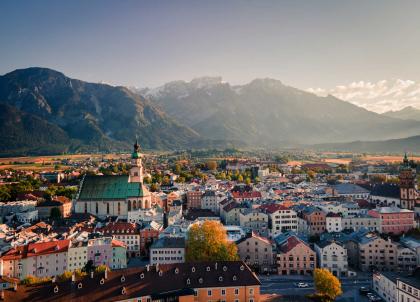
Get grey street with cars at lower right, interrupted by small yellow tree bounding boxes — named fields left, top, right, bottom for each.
left=259, top=275, right=372, bottom=301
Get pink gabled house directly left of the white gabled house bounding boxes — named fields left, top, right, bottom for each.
left=275, top=233, right=316, bottom=275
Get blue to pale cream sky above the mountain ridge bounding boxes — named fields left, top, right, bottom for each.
left=0, top=0, right=420, bottom=112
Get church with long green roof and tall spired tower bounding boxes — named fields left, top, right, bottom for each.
left=75, top=140, right=152, bottom=219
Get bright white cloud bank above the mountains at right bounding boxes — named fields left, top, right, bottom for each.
left=307, top=79, right=420, bottom=113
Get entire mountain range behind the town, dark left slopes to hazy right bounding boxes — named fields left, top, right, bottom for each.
left=0, top=67, right=420, bottom=156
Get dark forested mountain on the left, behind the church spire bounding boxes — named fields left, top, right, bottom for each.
left=0, top=68, right=199, bottom=155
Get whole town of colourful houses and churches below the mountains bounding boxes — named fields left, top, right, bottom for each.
left=0, top=141, right=420, bottom=302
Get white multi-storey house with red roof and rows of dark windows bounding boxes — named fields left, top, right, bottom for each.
left=259, top=203, right=298, bottom=238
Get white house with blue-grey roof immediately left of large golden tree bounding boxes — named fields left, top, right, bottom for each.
left=150, top=237, right=185, bottom=265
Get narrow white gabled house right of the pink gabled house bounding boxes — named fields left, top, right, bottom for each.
left=315, top=241, right=348, bottom=277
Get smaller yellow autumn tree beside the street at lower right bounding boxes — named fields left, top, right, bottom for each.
left=314, top=268, right=343, bottom=301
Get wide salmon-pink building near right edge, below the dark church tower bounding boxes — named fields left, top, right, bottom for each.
left=368, top=207, right=414, bottom=235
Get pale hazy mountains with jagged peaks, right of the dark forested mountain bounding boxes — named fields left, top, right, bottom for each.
left=138, top=77, right=420, bottom=147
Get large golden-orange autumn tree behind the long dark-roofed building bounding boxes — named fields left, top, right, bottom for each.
left=186, top=220, right=239, bottom=261
